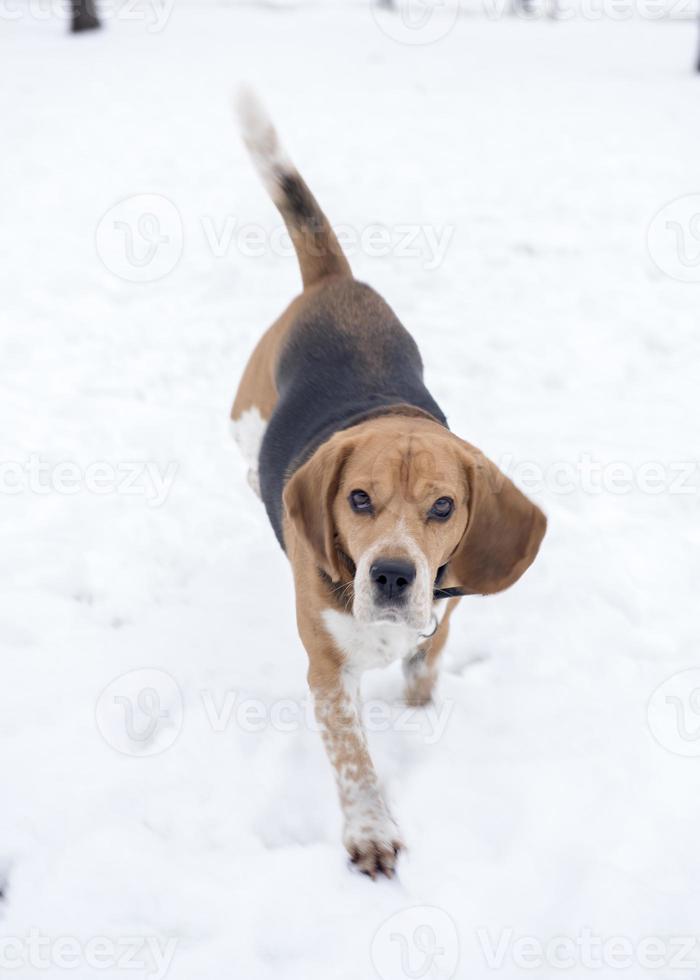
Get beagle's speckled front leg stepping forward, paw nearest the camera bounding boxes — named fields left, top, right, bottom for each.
left=309, top=649, right=403, bottom=878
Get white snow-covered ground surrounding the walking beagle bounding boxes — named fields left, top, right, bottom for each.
left=0, top=4, right=700, bottom=980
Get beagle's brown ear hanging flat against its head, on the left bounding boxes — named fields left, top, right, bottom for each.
left=283, top=433, right=354, bottom=581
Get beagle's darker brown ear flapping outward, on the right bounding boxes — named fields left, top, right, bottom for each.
left=450, top=443, right=547, bottom=595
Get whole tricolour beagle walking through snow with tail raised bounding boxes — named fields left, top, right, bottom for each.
left=231, top=94, right=546, bottom=878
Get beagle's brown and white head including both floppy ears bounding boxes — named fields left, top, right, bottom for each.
left=284, top=416, right=546, bottom=630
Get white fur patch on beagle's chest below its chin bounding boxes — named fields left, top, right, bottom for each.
left=321, top=609, right=420, bottom=673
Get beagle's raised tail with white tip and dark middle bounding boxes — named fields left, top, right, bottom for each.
left=236, top=89, right=352, bottom=287
